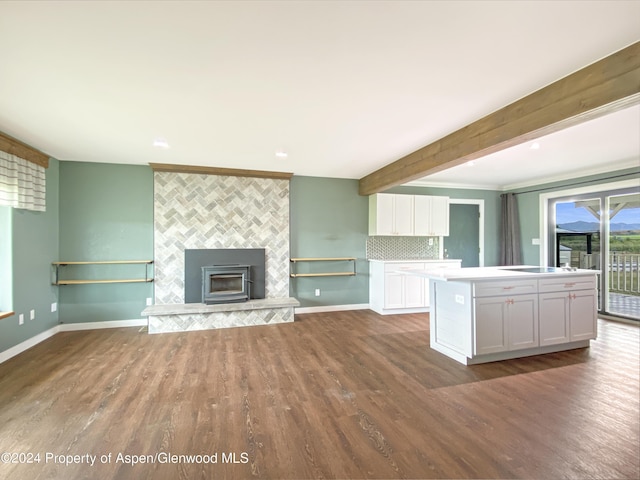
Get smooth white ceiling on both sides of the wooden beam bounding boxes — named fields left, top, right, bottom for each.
left=0, top=0, right=640, bottom=188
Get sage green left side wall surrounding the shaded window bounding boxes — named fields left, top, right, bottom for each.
left=0, top=159, right=59, bottom=352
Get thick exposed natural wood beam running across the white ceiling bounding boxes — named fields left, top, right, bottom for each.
left=359, top=42, right=640, bottom=195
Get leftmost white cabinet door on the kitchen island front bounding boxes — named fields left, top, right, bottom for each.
left=474, top=297, right=508, bottom=355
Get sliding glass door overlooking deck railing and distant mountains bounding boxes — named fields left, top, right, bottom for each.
left=548, top=189, right=640, bottom=320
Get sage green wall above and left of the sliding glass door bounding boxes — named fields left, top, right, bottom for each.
left=513, top=168, right=640, bottom=265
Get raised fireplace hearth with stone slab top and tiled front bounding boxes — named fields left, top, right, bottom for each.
left=142, top=298, right=300, bottom=333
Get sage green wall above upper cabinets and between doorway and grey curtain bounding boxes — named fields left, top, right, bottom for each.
left=388, top=186, right=501, bottom=267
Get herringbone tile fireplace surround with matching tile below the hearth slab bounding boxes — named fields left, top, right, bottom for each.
left=149, top=172, right=293, bottom=333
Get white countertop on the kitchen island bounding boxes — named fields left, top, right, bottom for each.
left=399, top=265, right=600, bottom=281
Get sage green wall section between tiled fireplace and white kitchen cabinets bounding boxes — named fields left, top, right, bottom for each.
left=289, top=176, right=369, bottom=307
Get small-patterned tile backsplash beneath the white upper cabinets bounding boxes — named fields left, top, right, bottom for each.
left=367, top=236, right=440, bottom=260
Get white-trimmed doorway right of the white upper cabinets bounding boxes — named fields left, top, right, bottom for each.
left=442, top=199, right=484, bottom=267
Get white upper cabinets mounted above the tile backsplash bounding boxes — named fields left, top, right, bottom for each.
left=369, top=193, right=449, bottom=237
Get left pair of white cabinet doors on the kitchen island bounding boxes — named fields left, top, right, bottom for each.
left=474, top=294, right=538, bottom=355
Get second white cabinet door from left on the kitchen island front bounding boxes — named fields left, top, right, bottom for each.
left=506, top=295, right=538, bottom=350
